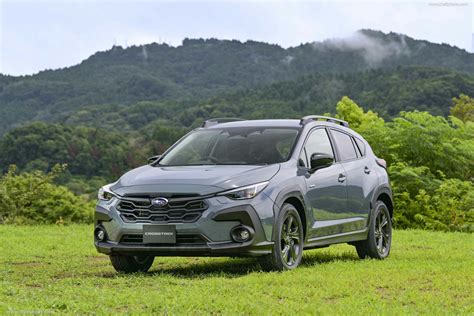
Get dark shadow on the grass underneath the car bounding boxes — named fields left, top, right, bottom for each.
left=100, top=251, right=359, bottom=279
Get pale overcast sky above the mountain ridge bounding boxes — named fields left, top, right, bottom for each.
left=0, top=0, right=474, bottom=75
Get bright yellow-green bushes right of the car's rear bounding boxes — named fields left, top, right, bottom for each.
left=336, top=97, right=474, bottom=232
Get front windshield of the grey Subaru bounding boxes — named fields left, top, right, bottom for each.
left=159, top=127, right=298, bottom=166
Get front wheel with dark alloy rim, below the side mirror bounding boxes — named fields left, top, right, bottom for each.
left=259, top=204, right=304, bottom=271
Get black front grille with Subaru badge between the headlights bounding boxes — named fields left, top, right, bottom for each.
left=117, top=197, right=208, bottom=223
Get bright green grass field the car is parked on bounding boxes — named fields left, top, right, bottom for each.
left=0, top=225, right=474, bottom=315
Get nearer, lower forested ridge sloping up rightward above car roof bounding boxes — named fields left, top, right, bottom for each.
left=57, top=66, right=474, bottom=134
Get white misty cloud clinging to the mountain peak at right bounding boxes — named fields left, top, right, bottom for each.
left=313, top=31, right=410, bottom=66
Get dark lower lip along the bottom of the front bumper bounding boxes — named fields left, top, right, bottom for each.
left=95, top=241, right=273, bottom=257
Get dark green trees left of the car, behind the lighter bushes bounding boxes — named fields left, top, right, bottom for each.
left=0, top=122, right=147, bottom=181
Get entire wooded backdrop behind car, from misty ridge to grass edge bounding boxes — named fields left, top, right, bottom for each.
left=0, top=30, right=474, bottom=232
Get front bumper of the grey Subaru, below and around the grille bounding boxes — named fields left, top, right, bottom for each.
left=95, top=197, right=273, bottom=256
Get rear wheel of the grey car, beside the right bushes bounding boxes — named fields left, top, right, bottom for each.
left=355, top=201, right=392, bottom=259
